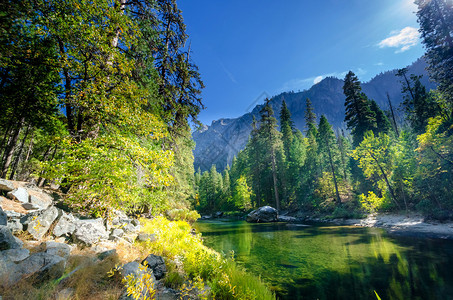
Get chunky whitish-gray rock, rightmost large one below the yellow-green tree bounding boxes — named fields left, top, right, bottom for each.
left=73, top=218, right=109, bottom=246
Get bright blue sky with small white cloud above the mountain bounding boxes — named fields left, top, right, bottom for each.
left=178, top=0, right=424, bottom=125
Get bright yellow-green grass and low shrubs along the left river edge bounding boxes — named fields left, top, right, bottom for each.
left=136, top=217, right=275, bottom=300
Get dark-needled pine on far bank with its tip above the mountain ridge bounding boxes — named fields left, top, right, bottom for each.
left=343, top=71, right=376, bottom=146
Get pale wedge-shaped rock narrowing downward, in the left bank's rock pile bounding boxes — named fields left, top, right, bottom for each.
left=20, top=206, right=59, bottom=240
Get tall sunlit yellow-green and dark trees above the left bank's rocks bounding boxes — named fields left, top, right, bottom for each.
left=0, top=0, right=204, bottom=216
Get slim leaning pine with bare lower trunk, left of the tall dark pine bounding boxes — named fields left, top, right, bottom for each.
left=318, top=115, right=341, bottom=205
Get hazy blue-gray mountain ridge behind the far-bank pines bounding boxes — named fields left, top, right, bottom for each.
left=193, top=59, right=435, bottom=171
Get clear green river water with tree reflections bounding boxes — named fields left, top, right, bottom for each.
left=195, top=220, right=453, bottom=300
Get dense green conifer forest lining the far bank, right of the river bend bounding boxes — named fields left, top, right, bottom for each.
left=195, top=1, right=453, bottom=219
